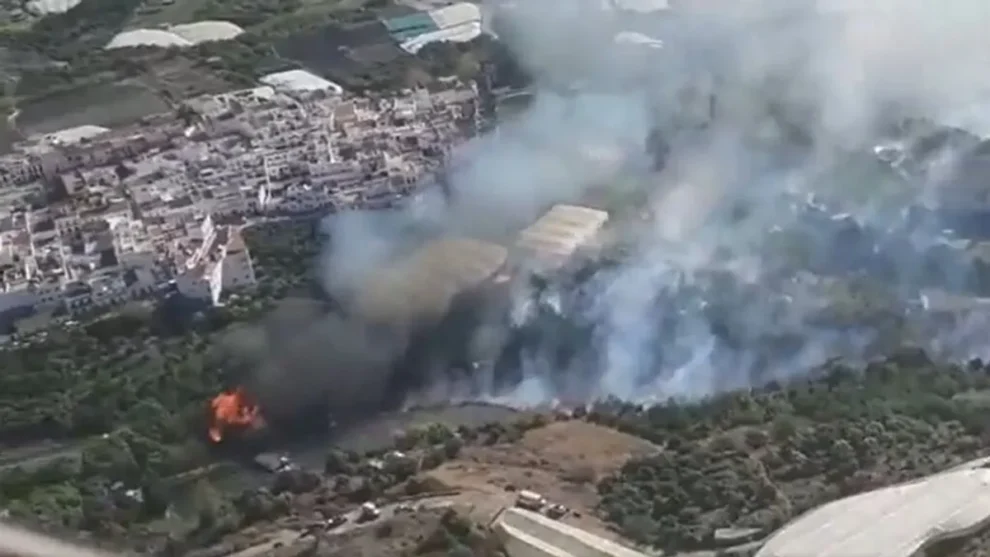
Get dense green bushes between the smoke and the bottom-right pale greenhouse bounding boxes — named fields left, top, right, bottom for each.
left=589, top=351, right=990, bottom=549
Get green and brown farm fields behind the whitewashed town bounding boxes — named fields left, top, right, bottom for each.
left=0, top=0, right=500, bottom=142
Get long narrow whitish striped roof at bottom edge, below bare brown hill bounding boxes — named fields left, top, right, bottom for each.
left=494, top=508, right=646, bottom=557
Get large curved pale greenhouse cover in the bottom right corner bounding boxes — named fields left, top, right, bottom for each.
left=756, top=468, right=990, bottom=557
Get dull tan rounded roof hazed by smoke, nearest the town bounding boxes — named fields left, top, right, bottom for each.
left=355, top=239, right=507, bottom=327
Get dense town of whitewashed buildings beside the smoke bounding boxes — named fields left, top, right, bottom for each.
left=0, top=70, right=478, bottom=322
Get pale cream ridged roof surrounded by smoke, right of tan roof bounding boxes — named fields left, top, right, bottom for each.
left=512, top=205, right=608, bottom=272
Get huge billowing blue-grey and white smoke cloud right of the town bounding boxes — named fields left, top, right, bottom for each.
left=312, top=0, right=990, bottom=403
